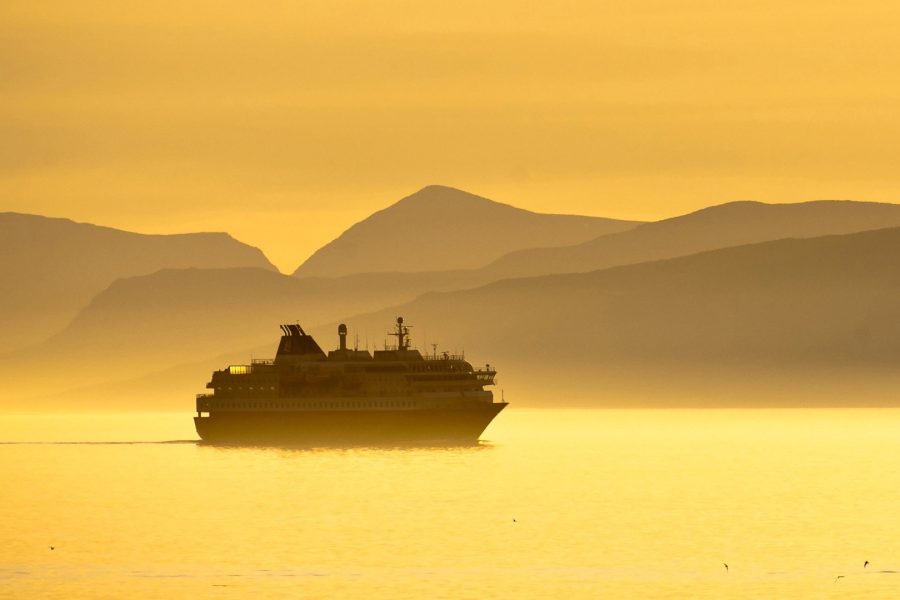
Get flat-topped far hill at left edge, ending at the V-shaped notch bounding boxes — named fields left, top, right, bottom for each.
left=0, top=213, right=274, bottom=351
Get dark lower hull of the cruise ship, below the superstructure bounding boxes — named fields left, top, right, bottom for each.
left=194, top=402, right=506, bottom=445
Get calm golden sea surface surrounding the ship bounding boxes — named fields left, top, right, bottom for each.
left=0, top=405, right=900, bottom=599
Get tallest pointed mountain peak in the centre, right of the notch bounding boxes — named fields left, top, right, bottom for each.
left=294, top=185, right=636, bottom=277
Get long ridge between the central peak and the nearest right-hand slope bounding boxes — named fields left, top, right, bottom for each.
left=482, top=200, right=900, bottom=279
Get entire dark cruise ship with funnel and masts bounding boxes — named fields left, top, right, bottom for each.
left=194, top=317, right=507, bottom=445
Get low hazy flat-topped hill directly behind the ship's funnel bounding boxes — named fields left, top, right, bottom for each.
left=44, top=269, right=486, bottom=366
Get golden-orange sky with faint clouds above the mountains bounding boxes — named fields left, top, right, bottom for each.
left=0, top=0, right=900, bottom=270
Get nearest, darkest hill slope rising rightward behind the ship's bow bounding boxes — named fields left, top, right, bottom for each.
left=322, top=228, right=900, bottom=406
